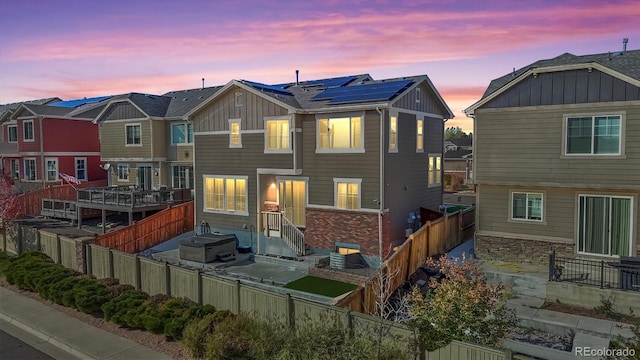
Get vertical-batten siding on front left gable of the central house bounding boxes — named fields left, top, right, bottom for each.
left=190, top=86, right=288, bottom=132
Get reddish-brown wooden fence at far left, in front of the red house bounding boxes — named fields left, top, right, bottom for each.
left=18, top=179, right=107, bottom=217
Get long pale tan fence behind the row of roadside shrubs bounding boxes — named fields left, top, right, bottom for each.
left=86, top=244, right=512, bottom=360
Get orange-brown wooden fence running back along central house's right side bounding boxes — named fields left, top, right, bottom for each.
left=337, top=207, right=475, bottom=314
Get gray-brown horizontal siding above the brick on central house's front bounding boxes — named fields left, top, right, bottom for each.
left=302, top=110, right=380, bottom=209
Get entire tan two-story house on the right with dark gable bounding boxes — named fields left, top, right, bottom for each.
left=465, top=50, right=640, bottom=263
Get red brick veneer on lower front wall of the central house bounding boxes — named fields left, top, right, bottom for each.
left=304, top=208, right=391, bottom=256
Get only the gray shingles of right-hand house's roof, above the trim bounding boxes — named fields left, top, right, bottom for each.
left=482, top=50, right=640, bottom=99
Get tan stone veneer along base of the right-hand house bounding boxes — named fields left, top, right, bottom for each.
left=475, top=234, right=575, bottom=265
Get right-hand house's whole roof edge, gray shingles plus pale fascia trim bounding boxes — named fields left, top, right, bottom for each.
left=465, top=50, right=640, bottom=114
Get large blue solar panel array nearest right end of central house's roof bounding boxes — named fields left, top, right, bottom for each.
left=311, top=80, right=413, bottom=104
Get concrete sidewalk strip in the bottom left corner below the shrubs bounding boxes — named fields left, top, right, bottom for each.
left=0, top=287, right=170, bottom=360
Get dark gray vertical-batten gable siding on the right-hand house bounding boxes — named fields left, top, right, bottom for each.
left=483, top=69, right=640, bottom=108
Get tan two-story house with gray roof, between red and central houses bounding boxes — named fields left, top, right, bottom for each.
left=94, top=87, right=220, bottom=190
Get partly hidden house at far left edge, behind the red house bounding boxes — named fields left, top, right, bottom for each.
left=0, top=97, right=60, bottom=177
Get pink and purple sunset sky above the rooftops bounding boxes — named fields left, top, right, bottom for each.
left=0, top=0, right=640, bottom=131
